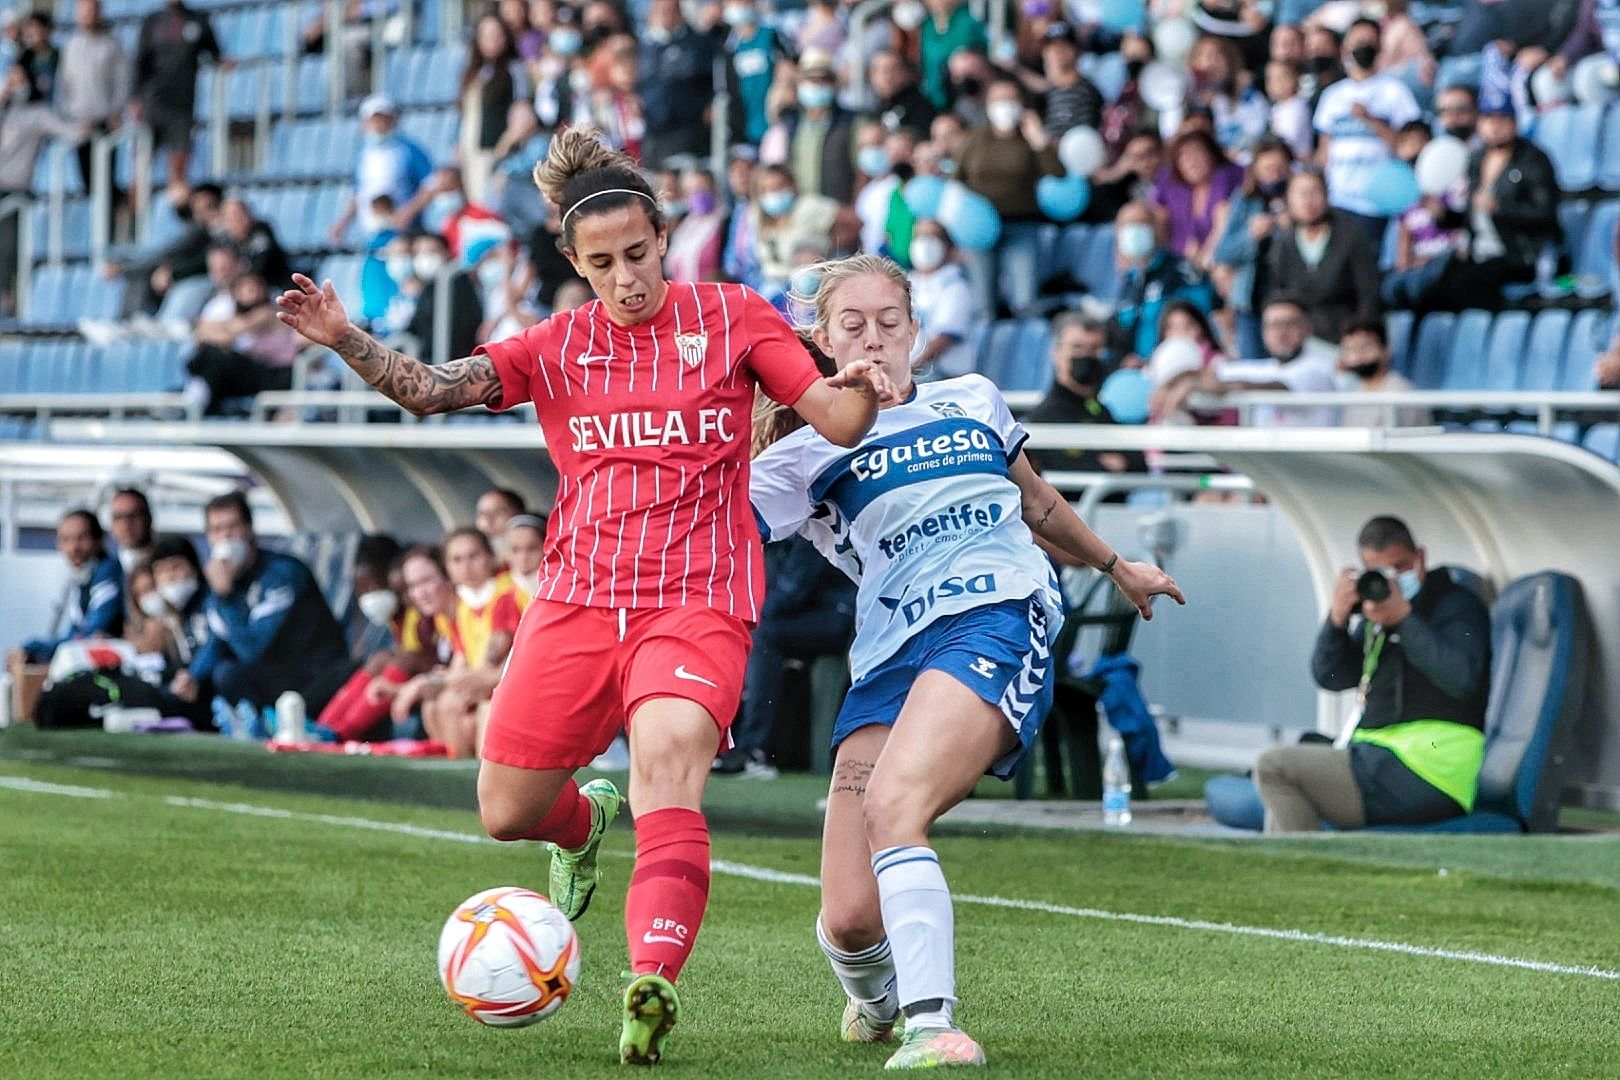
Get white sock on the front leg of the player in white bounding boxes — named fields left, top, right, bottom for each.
left=872, top=845, right=956, bottom=1028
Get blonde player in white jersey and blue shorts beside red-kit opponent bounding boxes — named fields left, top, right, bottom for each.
left=750, top=256, right=1186, bottom=1069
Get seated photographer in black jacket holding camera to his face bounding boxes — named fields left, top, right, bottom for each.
left=1254, top=517, right=1490, bottom=832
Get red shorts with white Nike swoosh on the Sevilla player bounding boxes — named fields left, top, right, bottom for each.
left=483, top=599, right=752, bottom=769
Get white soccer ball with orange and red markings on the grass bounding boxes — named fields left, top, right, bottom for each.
left=439, top=886, right=580, bottom=1028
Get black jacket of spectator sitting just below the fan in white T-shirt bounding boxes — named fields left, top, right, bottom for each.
left=1262, top=210, right=1382, bottom=342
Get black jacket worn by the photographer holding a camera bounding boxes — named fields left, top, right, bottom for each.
left=1311, top=570, right=1490, bottom=730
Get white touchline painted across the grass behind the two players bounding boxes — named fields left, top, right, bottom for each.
left=9, top=776, right=1620, bottom=981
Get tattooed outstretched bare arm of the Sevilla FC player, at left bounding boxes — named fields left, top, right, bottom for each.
left=275, top=274, right=501, bottom=416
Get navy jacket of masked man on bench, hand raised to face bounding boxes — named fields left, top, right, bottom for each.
left=188, top=549, right=348, bottom=682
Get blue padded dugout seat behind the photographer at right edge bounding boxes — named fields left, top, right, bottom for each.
left=1375, top=570, right=1589, bottom=832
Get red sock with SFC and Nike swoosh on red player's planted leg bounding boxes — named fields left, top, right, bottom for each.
left=624, top=806, right=710, bottom=981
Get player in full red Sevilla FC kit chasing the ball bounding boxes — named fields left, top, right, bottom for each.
left=279, top=131, right=893, bottom=1064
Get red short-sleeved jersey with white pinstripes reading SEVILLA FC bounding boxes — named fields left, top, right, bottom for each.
left=478, top=283, right=820, bottom=622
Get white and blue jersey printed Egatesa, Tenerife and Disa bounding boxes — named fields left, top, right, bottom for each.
left=748, top=376, right=1063, bottom=678
